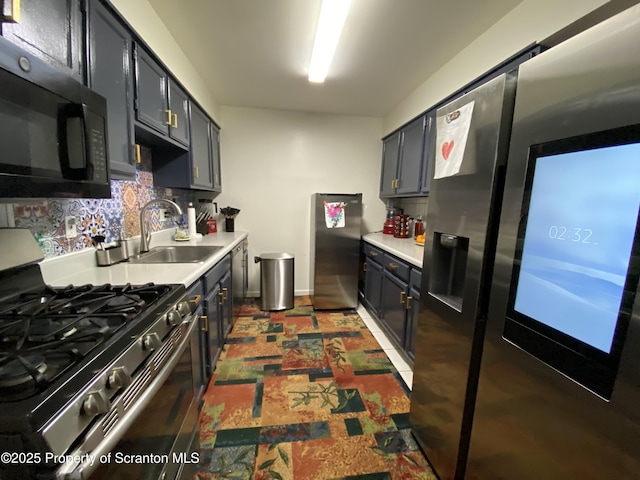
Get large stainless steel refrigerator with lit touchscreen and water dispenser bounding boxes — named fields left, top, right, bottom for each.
left=410, top=5, right=640, bottom=480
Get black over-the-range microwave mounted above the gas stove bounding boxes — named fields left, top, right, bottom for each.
left=0, top=37, right=111, bottom=198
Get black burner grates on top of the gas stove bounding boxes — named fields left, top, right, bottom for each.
left=0, top=283, right=170, bottom=401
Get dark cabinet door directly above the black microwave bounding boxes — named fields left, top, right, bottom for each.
left=0, top=0, right=84, bottom=82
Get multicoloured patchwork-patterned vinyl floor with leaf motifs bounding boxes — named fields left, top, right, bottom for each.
left=198, top=297, right=436, bottom=480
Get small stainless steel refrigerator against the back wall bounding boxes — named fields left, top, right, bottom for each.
left=309, top=193, right=362, bottom=310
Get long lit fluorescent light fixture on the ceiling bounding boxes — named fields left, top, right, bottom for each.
left=309, top=0, right=351, bottom=83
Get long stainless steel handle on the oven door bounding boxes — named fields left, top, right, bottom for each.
left=56, top=315, right=198, bottom=480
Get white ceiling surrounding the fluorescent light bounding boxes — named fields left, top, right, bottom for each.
left=148, top=0, right=522, bottom=117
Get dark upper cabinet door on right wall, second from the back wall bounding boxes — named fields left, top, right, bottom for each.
left=396, top=117, right=426, bottom=195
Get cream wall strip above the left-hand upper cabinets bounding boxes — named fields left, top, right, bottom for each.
left=111, top=0, right=218, bottom=121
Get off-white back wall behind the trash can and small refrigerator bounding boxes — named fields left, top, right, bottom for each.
left=210, top=106, right=385, bottom=295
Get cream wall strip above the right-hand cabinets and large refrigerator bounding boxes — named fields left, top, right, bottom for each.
left=383, top=0, right=607, bottom=135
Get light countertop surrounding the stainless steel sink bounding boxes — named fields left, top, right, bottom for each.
left=40, top=230, right=248, bottom=287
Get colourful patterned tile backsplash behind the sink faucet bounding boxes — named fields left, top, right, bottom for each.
left=13, top=147, right=190, bottom=257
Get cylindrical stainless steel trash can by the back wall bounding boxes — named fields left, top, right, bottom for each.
left=254, top=253, right=295, bottom=310
